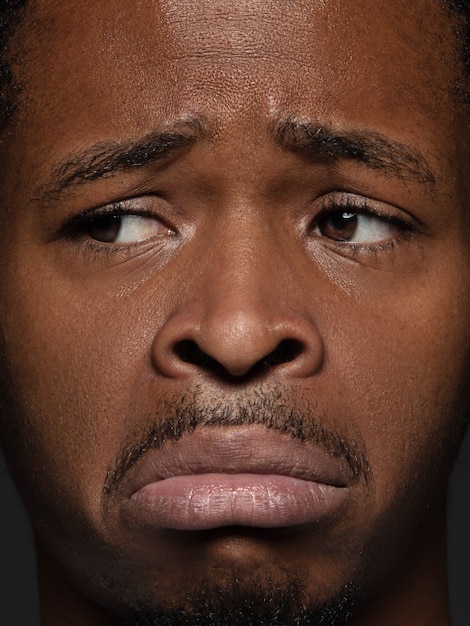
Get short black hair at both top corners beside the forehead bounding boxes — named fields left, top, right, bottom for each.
left=0, top=0, right=470, bottom=127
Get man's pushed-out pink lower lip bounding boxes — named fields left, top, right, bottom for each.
left=128, top=474, right=348, bottom=530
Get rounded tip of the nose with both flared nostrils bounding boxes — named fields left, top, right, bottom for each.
left=152, top=311, right=323, bottom=379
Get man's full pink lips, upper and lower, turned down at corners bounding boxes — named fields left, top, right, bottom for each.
left=122, top=425, right=350, bottom=531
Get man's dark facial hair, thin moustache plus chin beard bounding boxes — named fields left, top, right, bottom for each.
left=105, top=388, right=369, bottom=626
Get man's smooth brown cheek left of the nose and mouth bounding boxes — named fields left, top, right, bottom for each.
left=0, top=272, right=158, bottom=523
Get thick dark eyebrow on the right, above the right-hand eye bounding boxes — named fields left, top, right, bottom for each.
left=272, top=117, right=435, bottom=187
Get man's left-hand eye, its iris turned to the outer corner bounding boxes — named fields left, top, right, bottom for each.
left=83, top=214, right=173, bottom=244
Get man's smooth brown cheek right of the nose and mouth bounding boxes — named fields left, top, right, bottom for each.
left=330, top=279, right=470, bottom=510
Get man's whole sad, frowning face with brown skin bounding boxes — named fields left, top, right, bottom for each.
left=0, top=0, right=470, bottom=623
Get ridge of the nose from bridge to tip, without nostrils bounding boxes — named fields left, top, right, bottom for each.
left=197, top=215, right=298, bottom=375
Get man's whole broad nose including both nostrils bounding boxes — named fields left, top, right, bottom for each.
left=152, top=234, right=324, bottom=379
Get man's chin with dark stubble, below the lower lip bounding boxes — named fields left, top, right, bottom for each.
left=56, top=528, right=370, bottom=626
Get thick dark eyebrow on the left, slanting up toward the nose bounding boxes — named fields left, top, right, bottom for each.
left=40, top=118, right=207, bottom=201
